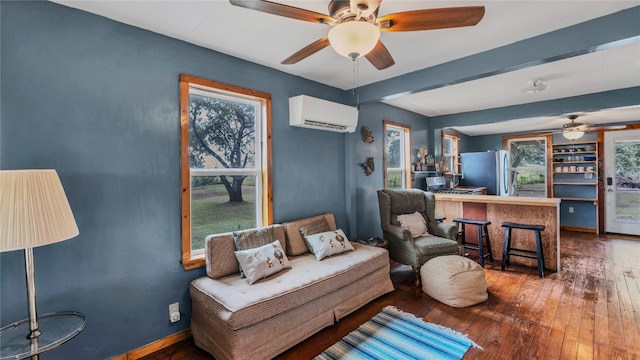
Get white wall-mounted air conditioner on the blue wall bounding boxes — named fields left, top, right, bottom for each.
left=289, top=95, right=358, bottom=132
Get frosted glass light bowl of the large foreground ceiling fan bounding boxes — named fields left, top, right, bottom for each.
left=329, top=21, right=380, bottom=59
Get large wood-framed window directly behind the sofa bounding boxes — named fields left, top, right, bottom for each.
left=180, top=74, right=272, bottom=269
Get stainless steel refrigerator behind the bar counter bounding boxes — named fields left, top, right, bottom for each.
left=460, top=150, right=511, bottom=196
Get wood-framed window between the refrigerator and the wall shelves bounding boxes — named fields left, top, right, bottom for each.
left=504, top=134, right=551, bottom=197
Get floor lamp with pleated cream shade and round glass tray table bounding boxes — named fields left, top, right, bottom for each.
left=0, top=170, right=85, bottom=359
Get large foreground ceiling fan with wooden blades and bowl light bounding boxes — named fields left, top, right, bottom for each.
left=229, top=0, right=484, bottom=70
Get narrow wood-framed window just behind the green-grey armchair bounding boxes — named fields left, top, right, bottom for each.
left=383, top=120, right=411, bottom=189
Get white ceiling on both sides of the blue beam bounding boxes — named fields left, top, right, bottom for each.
left=54, top=0, right=640, bottom=135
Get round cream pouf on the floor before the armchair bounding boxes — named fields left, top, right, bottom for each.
left=420, top=255, right=489, bottom=307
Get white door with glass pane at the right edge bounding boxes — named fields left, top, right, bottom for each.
left=604, top=130, right=640, bottom=235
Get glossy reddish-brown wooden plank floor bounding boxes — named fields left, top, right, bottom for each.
left=143, top=232, right=640, bottom=360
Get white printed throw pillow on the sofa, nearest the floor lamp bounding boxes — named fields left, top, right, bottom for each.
left=235, top=240, right=291, bottom=284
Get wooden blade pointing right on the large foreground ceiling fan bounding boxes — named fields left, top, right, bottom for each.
left=378, top=6, right=484, bottom=31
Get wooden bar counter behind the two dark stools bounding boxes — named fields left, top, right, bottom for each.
left=435, top=193, right=560, bottom=271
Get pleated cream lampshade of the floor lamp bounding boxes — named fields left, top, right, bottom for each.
left=0, top=170, right=79, bottom=252
